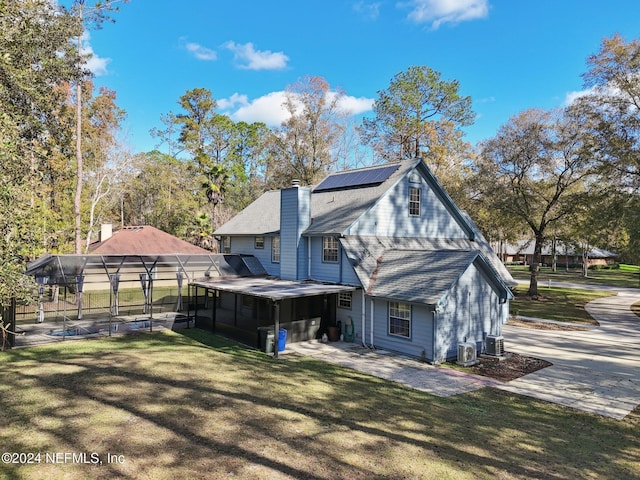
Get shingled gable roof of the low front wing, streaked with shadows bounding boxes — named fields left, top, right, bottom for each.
left=367, top=249, right=510, bottom=306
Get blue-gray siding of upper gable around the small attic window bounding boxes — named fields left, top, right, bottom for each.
left=345, top=169, right=467, bottom=238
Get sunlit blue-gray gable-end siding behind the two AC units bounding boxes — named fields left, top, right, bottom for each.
left=437, top=265, right=509, bottom=361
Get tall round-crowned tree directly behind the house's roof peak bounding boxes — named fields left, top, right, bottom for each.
left=362, top=66, right=475, bottom=165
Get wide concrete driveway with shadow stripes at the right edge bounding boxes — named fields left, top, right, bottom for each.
left=497, top=284, right=640, bottom=419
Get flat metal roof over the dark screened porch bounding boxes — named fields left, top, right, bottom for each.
left=192, top=277, right=357, bottom=301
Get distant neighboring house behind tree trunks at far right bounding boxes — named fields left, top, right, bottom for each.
left=499, top=240, right=618, bottom=267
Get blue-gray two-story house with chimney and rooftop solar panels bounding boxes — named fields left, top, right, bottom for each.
left=202, top=159, right=515, bottom=363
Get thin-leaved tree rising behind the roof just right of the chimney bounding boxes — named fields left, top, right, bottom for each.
left=271, top=76, right=344, bottom=187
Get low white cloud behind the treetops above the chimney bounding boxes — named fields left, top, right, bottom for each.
left=225, top=91, right=374, bottom=127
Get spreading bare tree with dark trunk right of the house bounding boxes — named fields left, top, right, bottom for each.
left=476, top=110, right=594, bottom=297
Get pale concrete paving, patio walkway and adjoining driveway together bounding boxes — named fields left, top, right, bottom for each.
left=284, top=284, right=640, bottom=420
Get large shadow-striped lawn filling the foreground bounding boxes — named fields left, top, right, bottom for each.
left=0, top=329, right=640, bottom=480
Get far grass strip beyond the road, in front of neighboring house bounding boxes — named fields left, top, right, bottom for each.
left=508, top=265, right=640, bottom=288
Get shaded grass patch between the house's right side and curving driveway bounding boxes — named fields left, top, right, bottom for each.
left=509, top=286, right=613, bottom=325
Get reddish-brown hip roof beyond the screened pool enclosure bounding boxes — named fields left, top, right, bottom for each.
left=89, top=225, right=211, bottom=255
